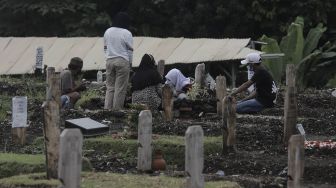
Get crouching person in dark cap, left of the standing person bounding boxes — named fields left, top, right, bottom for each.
left=61, top=57, right=86, bottom=109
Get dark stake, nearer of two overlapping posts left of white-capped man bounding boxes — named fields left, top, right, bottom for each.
left=222, top=97, right=237, bottom=153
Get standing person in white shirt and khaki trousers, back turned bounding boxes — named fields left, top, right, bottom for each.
left=104, top=12, right=133, bottom=110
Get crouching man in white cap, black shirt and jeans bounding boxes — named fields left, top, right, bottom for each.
left=231, top=53, right=277, bottom=114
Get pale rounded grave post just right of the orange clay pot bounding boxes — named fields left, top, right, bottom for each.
left=185, top=126, right=204, bottom=188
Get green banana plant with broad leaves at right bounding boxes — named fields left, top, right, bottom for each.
left=261, top=17, right=336, bottom=88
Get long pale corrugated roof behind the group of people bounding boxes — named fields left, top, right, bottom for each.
left=0, top=37, right=255, bottom=75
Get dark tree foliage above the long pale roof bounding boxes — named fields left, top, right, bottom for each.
left=0, top=0, right=336, bottom=39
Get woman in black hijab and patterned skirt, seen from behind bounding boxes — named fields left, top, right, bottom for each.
left=131, top=54, right=162, bottom=111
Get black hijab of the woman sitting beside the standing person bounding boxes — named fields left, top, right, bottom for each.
left=131, top=54, right=162, bottom=92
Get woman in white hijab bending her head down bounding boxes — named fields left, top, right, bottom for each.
left=165, top=69, right=191, bottom=99
